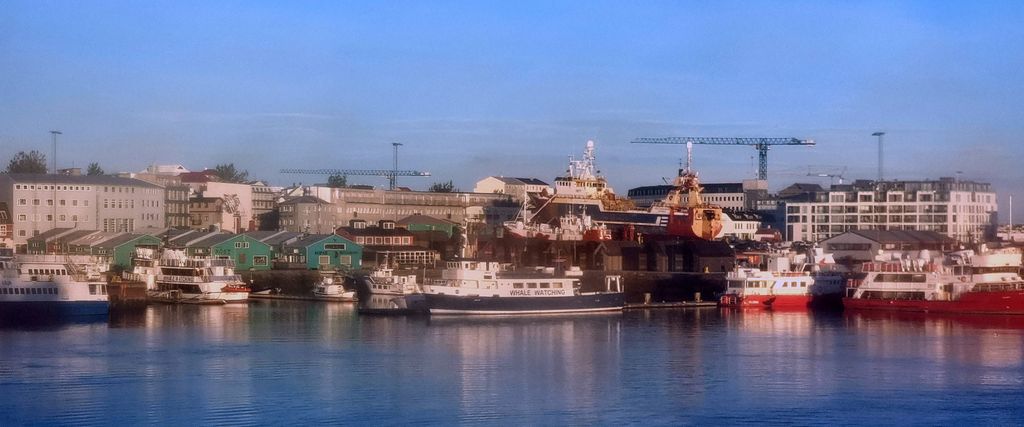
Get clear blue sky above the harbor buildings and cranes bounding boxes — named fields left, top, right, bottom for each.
left=0, top=1, right=1024, bottom=222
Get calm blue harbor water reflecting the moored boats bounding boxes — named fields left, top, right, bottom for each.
left=0, top=301, right=1024, bottom=425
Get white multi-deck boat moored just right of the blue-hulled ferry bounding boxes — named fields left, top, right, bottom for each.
left=147, top=249, right=249, bottom=304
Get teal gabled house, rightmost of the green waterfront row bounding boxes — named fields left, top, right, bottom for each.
left=278, top=234, right=362, bottom=270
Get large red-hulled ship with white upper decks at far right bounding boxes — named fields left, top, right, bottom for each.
left=843, top=247, right=1024, bottom=314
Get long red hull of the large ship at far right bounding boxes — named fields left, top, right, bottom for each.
left=843, top=291, right=1024, bottom=314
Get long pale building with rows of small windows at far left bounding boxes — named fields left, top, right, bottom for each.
left=0, top=174, right=165, bottom=246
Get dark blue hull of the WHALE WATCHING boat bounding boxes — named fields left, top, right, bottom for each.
left=424, top=293, right=625, bottom=314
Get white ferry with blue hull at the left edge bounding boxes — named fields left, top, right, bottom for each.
left=0, top=249, right=110, bottom=318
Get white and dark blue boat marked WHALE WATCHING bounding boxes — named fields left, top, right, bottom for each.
left=415, top=260, right=625, bottom=314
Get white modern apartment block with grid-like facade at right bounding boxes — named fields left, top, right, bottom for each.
left=785, top=178, right=997, bottom=243
